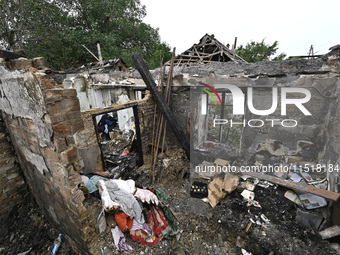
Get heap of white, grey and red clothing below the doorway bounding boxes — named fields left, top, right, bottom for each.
left=96, top=179, right=178, bottom=251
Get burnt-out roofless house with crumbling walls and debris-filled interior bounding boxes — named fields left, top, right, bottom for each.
left=0, top=40, right=340, bottom=254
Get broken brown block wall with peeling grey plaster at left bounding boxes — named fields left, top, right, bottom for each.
left=0, top=59, right=101, bottom=254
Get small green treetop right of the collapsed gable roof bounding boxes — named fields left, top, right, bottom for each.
left=236, top=39, right=287, bottom=63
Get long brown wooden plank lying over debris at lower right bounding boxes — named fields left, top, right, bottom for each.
left=246, top=172, right=340, bottom=201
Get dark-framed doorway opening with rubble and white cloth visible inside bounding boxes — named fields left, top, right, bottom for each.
left=92, top=104, right=143, bottom=178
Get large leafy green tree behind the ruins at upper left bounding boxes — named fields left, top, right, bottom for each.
left=0, top=0, right=171, bottom=69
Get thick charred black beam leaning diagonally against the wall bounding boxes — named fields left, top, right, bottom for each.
left=132, top=53, right=190, bottom=159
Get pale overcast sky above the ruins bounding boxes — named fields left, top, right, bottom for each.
left=140, top=0, right=340, bottom=57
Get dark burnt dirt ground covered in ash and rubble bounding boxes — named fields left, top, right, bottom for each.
left=0, top=147, right=340, bottom=255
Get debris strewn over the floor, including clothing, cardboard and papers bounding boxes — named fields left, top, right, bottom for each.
left=0, top=147, right=340, bottom=255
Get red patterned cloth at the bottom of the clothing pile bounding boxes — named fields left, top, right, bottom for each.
left=130, top=206, right=168, bottom=246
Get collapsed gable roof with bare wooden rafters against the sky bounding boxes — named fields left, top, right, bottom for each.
left=168, top=34, right=247, bottom=65
